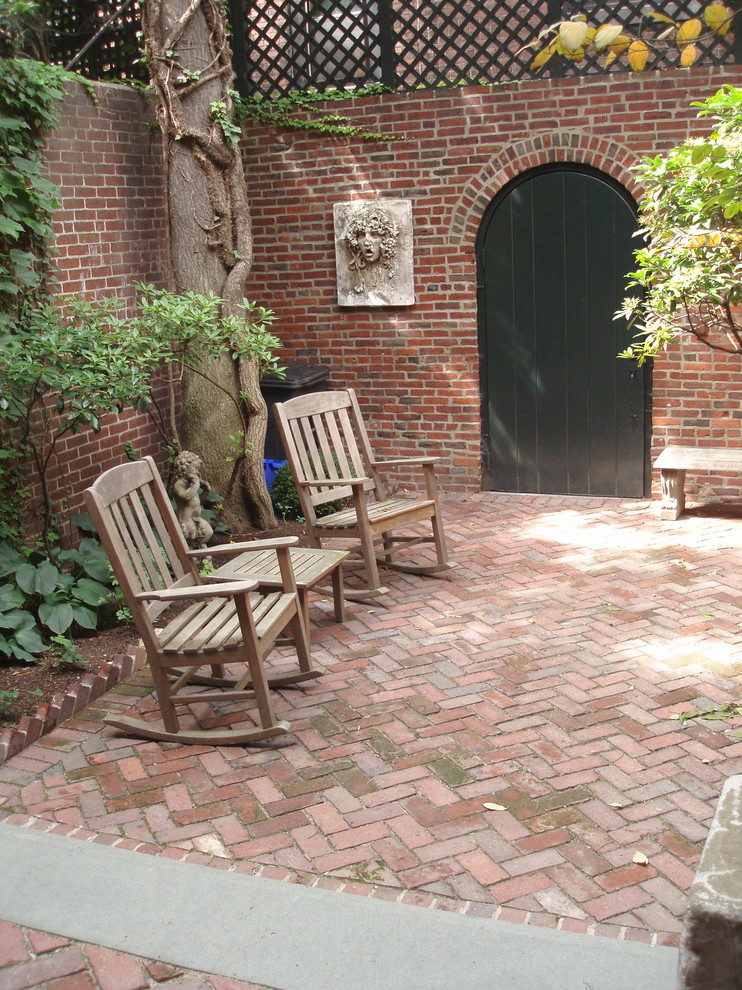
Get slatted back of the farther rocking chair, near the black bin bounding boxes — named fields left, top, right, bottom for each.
left=273, top=389, right=385, bottom=515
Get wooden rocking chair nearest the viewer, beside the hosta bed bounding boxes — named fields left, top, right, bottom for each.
left=85, top=457, right=322, bottom=746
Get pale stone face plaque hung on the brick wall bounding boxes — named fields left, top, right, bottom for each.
left=333, top=199, right=415, bottom=306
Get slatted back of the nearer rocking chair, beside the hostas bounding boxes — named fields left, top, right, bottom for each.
left=85, top=457, right=199, bottom=619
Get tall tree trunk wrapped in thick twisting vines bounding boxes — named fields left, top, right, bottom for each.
left=143, top=0, right=275, bottom=529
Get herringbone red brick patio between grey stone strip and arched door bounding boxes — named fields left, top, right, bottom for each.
left=0, top=493, right=742, bottom=964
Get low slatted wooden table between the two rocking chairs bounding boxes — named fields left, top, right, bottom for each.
left=209, top=547, right=348, bottom=626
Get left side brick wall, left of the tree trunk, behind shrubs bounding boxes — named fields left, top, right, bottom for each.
left=39, top=83, right=167, bottom=528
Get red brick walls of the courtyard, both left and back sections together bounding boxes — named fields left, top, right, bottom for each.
left=48, top=68, right=742, bottom=512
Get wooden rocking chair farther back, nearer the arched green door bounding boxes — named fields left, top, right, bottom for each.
left=273, top=389, right=454, bottom=600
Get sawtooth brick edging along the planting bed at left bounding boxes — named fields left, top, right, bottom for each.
left=0, top=647, right=144, bottom=766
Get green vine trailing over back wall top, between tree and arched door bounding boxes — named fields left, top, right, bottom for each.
left=240, top=83, right=394, bottom=141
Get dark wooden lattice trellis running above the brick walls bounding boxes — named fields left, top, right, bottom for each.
left=49, top=0, right=742, bottom=97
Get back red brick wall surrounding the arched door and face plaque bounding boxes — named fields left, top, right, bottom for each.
left=244, top=68, right=742, bottom=504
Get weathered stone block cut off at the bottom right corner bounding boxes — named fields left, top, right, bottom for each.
left=678, top=776, right=742, bottom=990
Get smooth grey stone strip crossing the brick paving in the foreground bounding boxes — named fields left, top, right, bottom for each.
left=0, top=825, right=677, bottom=990
